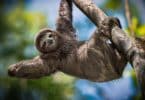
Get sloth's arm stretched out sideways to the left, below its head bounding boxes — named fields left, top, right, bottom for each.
left=8, top=57, right=55, bottom=79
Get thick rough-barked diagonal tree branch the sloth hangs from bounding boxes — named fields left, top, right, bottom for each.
left=72, top=0, right=145, bottom=98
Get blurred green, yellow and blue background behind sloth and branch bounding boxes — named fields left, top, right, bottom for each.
left=0, top=0, right=145, bottom=100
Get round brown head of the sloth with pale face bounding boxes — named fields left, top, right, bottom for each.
left=35, top=29, right=60, bottom=53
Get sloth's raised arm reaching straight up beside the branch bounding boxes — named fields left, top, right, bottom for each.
left=56, top=0, right=76, bottom=37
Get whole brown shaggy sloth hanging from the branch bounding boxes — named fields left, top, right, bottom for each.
left=8, top=0, right=127, bottom=82
